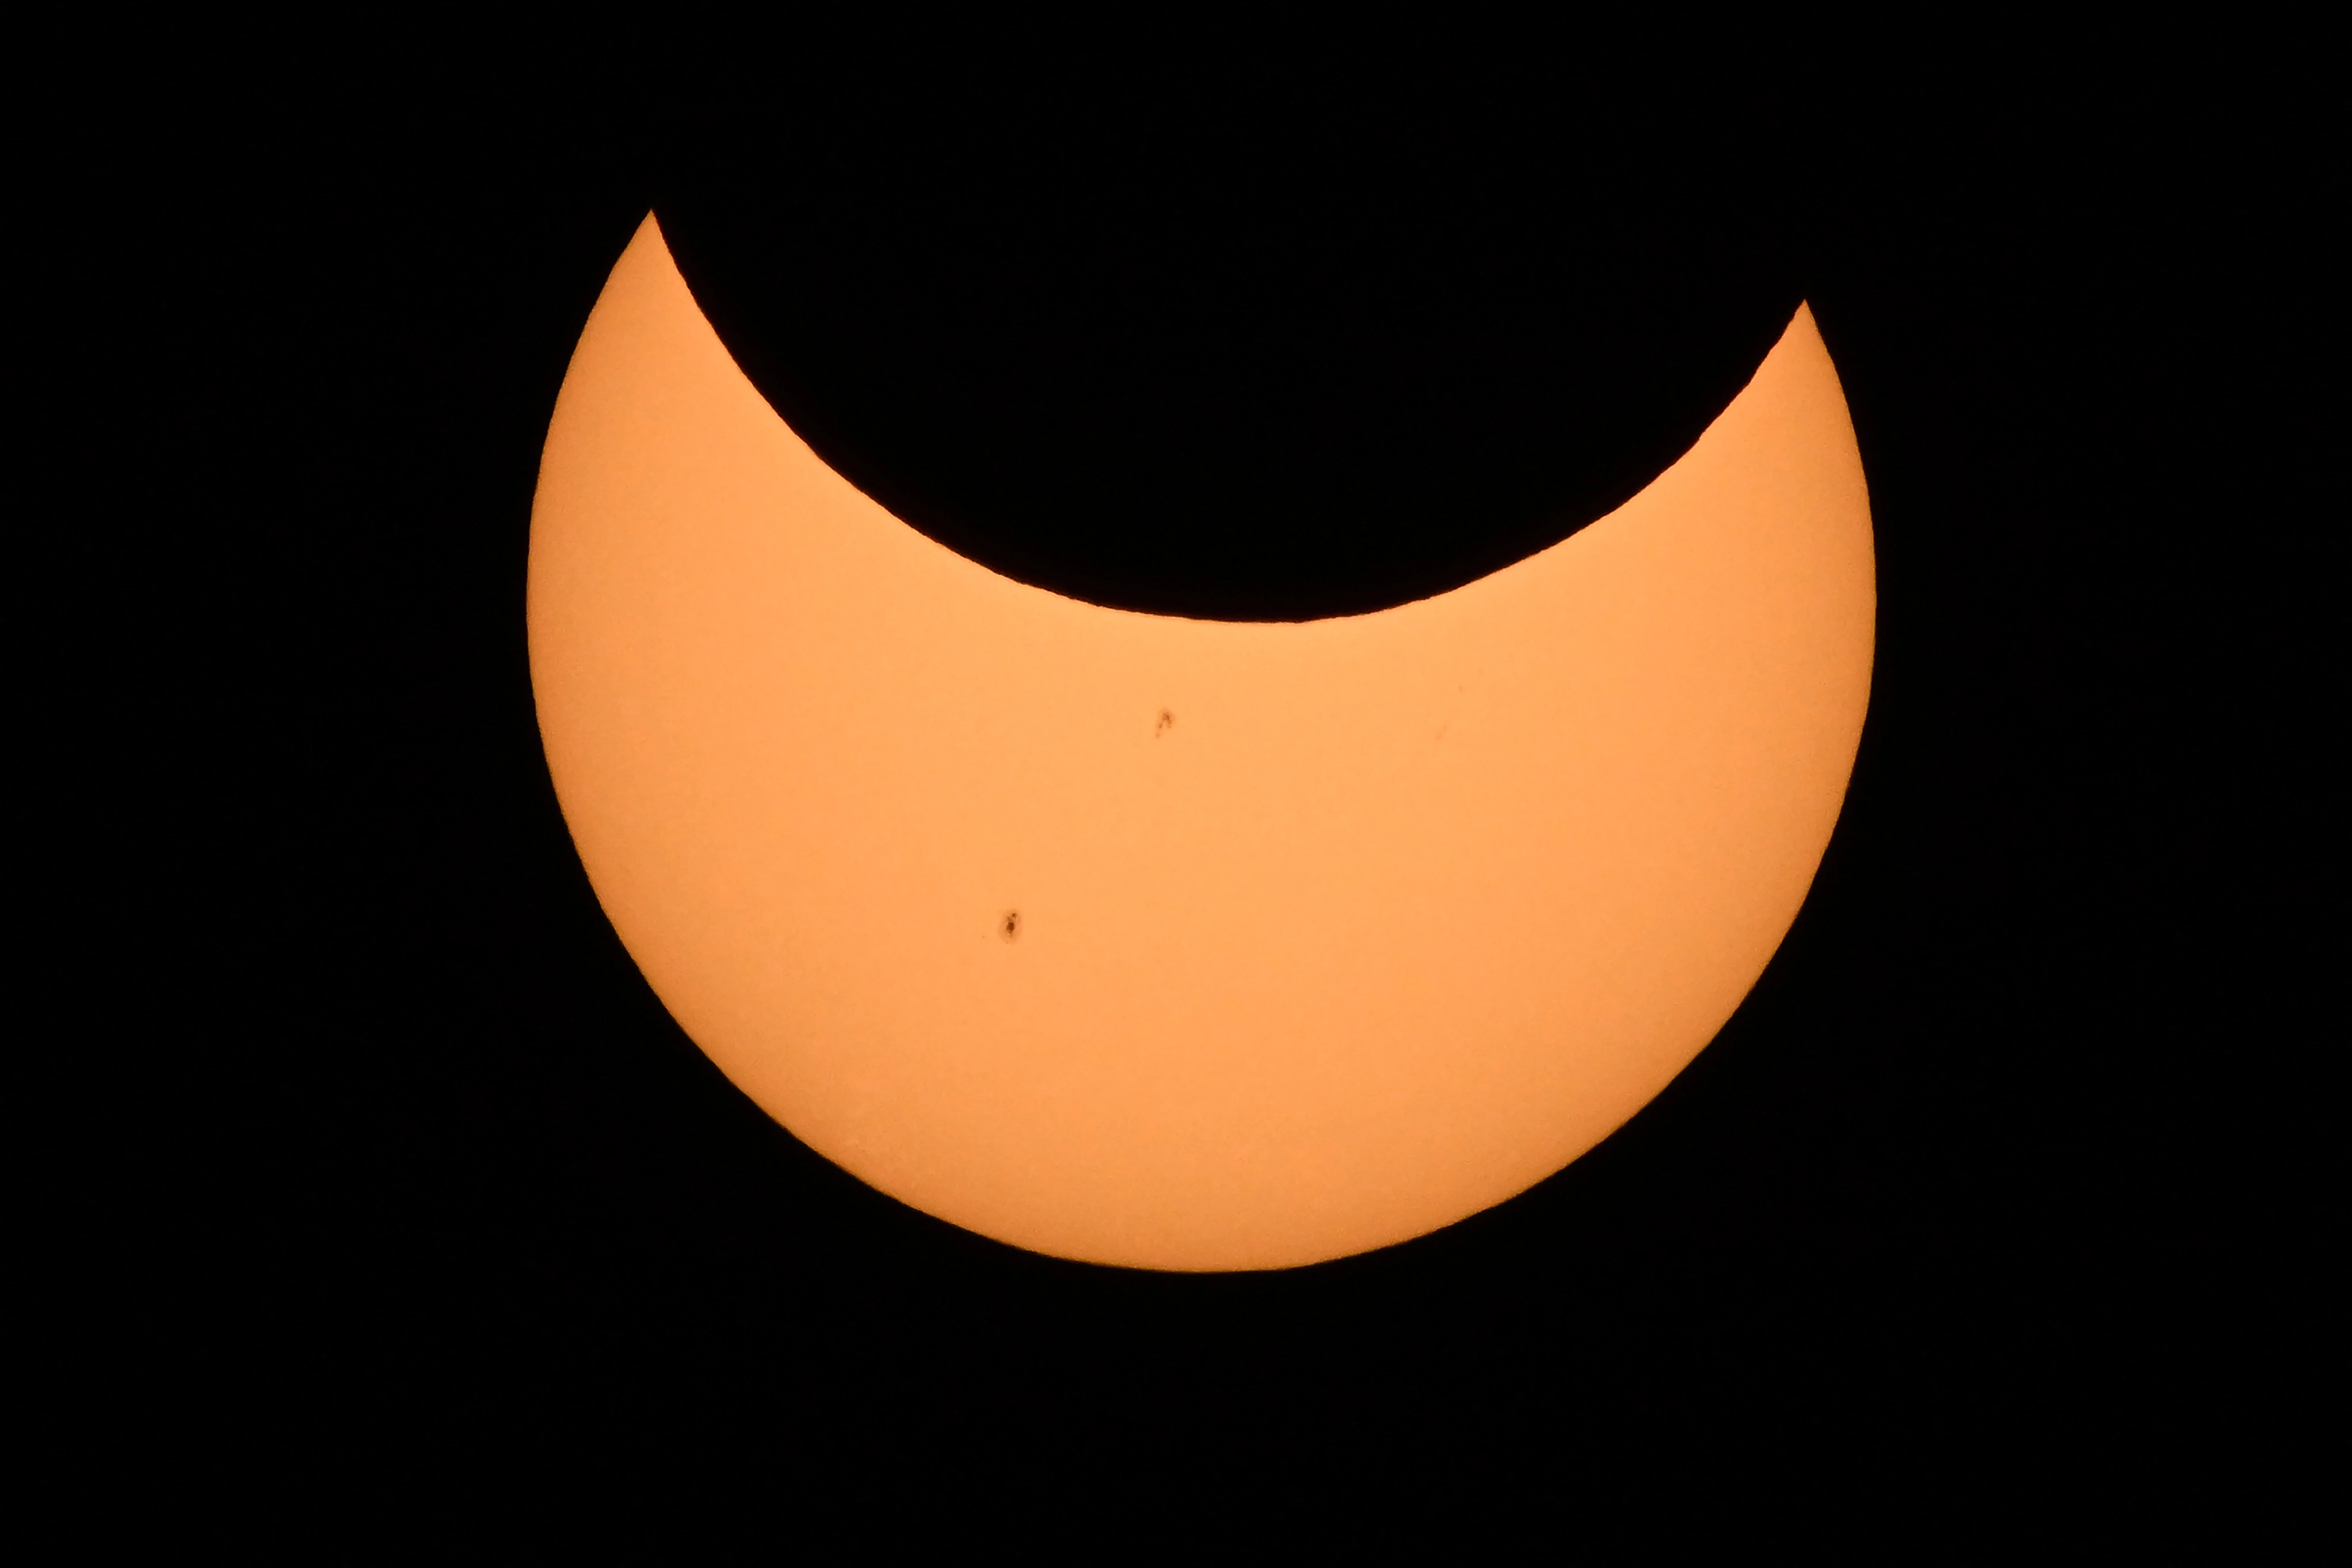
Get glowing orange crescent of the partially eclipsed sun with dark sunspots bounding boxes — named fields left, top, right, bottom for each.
left=527, top=216, right=1875, bottom=1269
